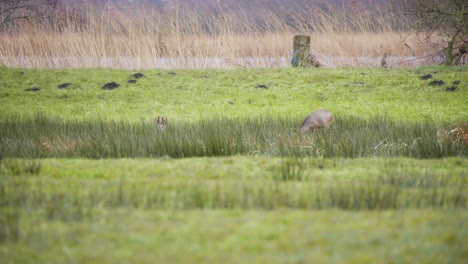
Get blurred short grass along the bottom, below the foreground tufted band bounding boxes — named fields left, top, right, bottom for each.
left=0, top=209, right=468, bottom=264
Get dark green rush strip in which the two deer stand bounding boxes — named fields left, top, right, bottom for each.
left=0, top=115, right=468, bottom=158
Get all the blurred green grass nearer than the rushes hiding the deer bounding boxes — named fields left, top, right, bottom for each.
left=0, top=156, right=468, bottom=263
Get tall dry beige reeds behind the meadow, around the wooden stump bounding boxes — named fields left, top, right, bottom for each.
left=0, top=2, right=434, bottom=68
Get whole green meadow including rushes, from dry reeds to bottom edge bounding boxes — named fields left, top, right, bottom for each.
left=0, top=67, right=468, bottom=263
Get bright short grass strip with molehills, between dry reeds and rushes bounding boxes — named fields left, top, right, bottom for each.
left=0, top=67, right=468, bottom=121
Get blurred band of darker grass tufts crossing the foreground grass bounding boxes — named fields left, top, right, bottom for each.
left=0, top=161, right=468, bottom=217
